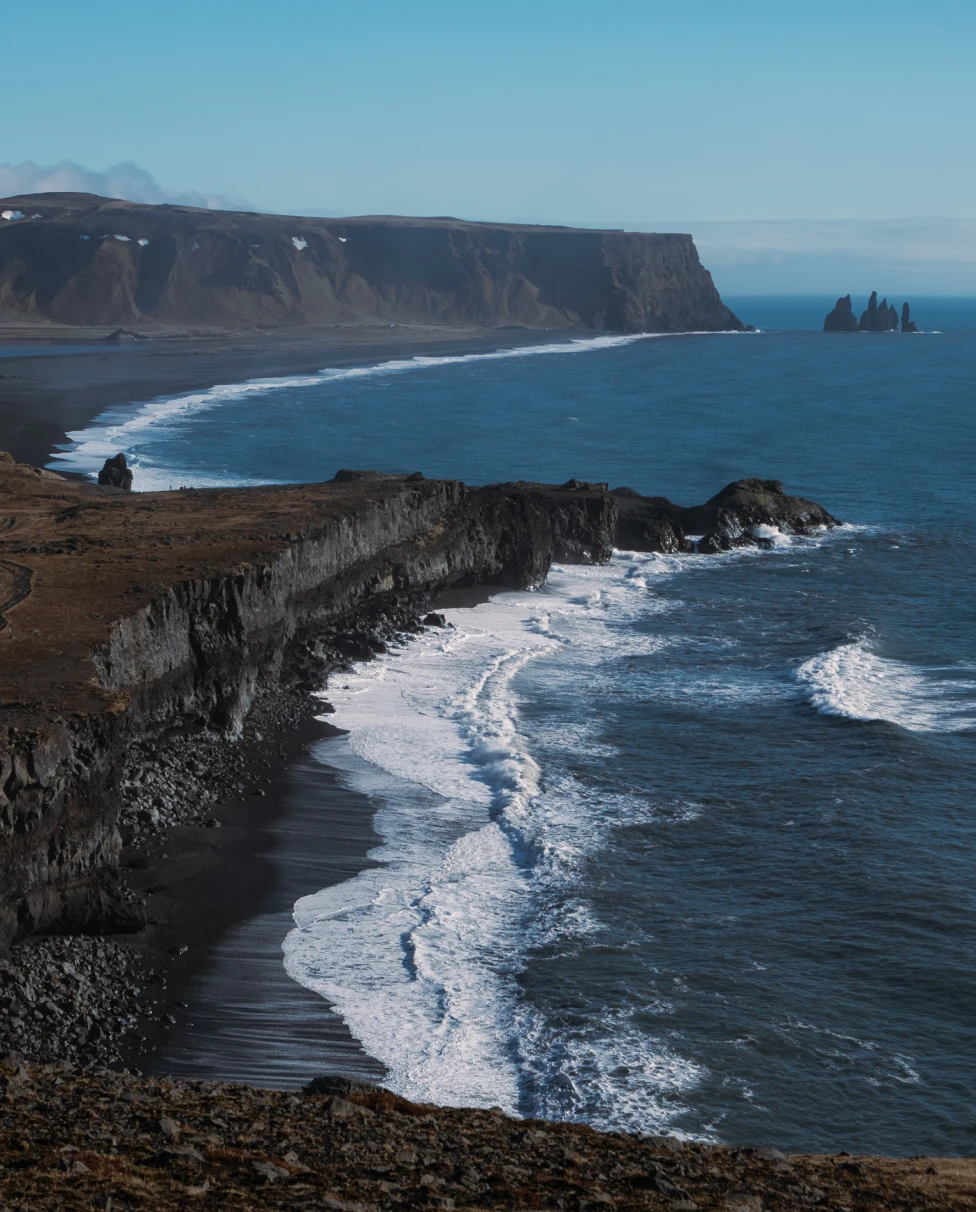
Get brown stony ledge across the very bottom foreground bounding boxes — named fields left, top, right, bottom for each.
left=0, top=1071, right=976, bottom=1212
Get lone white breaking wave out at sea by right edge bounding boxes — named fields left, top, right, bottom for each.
left=795, top=639, right=976, bottom=732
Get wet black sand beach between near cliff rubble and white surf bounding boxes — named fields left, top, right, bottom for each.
left=124, top=720, right=384, bottom=1088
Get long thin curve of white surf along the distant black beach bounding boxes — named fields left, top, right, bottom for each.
left=48, top=332, right=740, bottom=492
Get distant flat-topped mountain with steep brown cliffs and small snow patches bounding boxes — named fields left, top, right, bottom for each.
left=0, top=194, right=742, bottom=332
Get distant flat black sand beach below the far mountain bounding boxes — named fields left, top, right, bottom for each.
left=0, top=325, right=579, bottom=474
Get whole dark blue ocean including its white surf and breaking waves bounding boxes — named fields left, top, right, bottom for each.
left=51, top=298, right=976, bottom=1155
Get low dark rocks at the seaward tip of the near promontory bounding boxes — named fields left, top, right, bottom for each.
left=612, top=480, right=837, bottom=554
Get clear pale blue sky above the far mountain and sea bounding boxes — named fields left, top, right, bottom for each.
left=0, top=0, right=976, bottom=293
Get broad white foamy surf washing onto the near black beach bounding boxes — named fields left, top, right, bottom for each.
left=284, top=556, right=717, bottom=1131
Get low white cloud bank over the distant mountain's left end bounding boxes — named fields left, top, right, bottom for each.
left=0, top=160, right=253, bottom=211
